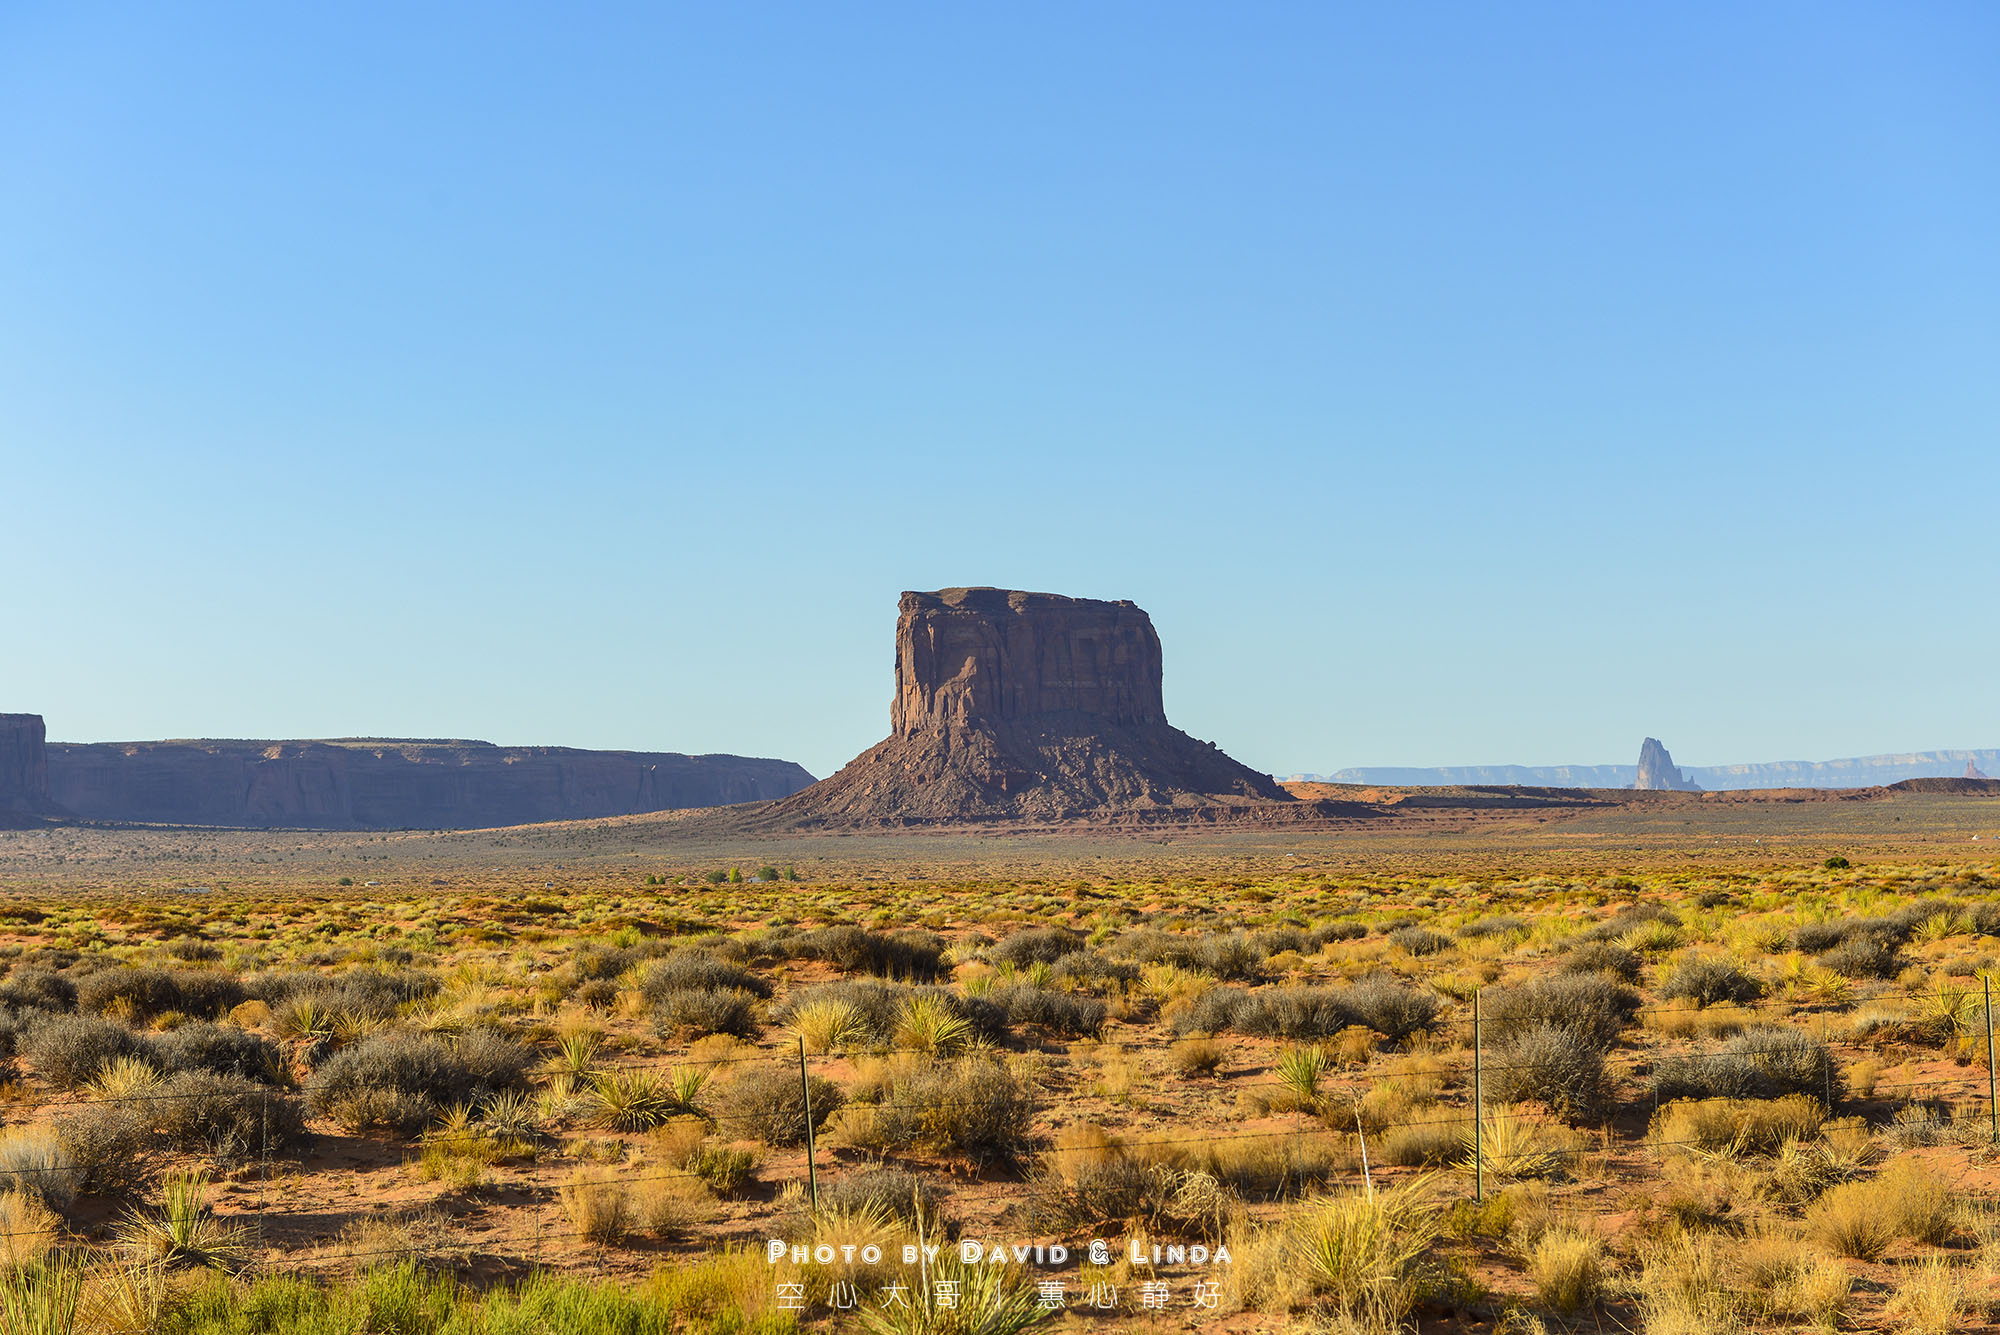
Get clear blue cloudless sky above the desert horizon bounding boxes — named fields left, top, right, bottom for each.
left=0, top=0, right=2000, bottom=773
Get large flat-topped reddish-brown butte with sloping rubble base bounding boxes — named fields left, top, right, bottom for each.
left=758, top=588, right=1292, bottom=827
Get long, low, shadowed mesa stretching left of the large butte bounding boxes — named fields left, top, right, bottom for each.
left=48, top=739, right=812, bottom=829
